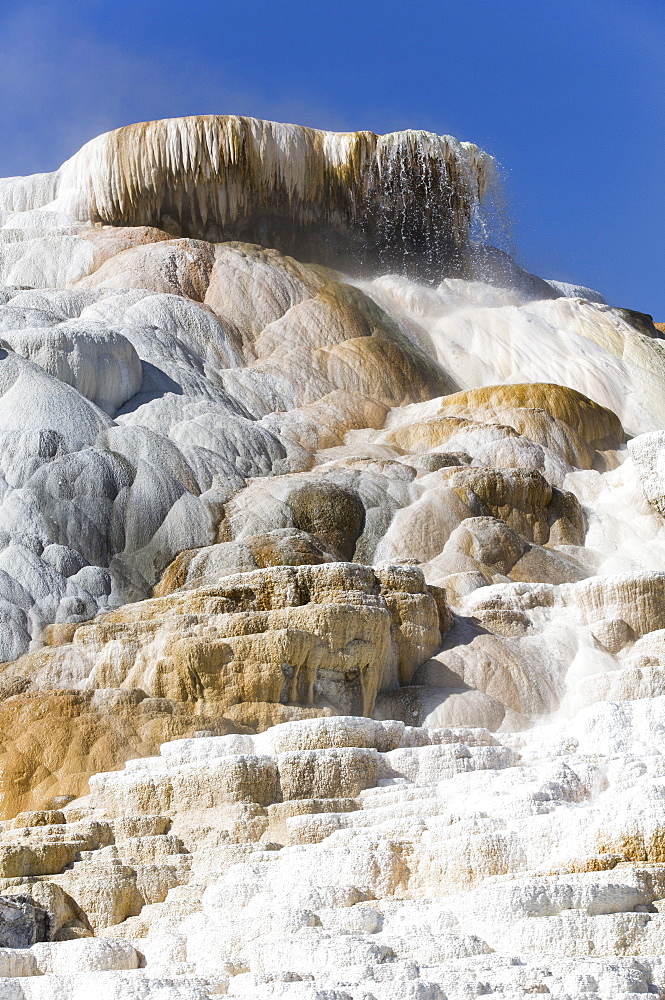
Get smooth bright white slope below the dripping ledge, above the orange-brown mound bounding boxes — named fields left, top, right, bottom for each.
left=359, top=274, right=665, bottom=435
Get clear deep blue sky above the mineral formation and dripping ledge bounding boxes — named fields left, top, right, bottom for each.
left=0, top=0, right=665, bottom=321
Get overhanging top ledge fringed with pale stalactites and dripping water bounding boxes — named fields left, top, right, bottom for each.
left=0, top=115, right=494, bottom=273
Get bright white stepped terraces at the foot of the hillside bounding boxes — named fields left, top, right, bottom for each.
left=0, top=712, right=665, bottom=1000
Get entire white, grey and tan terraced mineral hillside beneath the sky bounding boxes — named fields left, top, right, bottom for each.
left=0, top=116, right=665, bottom=1000
